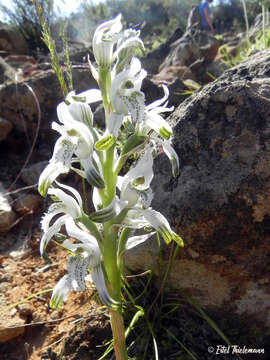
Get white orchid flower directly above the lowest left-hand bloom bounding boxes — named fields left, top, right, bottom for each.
left=40, top=183, right=83, bottom=256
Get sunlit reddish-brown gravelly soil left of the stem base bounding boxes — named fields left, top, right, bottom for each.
left=0, top=233, right=111, bottom=360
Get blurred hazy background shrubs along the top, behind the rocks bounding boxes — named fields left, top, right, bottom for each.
left=0, top=0, right=268, bottom=51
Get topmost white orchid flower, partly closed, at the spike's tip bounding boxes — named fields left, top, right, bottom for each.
left=93, top=14, right=122, bottom=68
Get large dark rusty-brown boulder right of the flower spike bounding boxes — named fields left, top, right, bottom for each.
left=127, top=51, right=270, bottom=327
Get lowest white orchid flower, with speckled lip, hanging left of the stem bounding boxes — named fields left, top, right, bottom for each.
left=50, top=219, right=117, bottom=308
